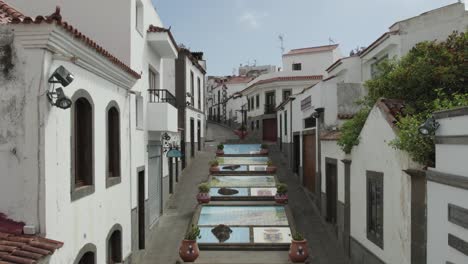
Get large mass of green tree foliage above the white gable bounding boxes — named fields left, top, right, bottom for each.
left=338, top=31, right=468, bottom=164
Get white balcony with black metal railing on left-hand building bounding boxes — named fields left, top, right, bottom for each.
left=146, top=89, right=177, bottom=132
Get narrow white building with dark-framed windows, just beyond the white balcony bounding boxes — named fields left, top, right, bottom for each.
left=176, top=49, right=206, bottom=168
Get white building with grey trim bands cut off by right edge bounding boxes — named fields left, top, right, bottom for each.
left=427, top=107, right=468, bottom=264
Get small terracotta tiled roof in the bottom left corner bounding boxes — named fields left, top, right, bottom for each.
left=0, top=213, right=63, bottom=264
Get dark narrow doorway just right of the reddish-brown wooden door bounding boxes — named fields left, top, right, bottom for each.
left=325, top=158, right=338, bottom=224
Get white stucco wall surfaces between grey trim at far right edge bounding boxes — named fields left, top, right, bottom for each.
left=427, top=112, right=468, bottom=264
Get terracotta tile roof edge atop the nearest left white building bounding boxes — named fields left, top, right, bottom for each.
left=0, top=0, right=141, bottom=79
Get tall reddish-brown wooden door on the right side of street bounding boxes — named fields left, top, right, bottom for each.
left=302, top=134, right=316, bottom=193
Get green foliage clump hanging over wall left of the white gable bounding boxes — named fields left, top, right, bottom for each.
left=337, top=106, right=370, bottom=153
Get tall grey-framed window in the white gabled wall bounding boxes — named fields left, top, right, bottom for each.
left=366, top=171, right=384, bottom=249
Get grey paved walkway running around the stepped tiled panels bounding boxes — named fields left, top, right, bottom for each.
left=141, top=124, right=347, bottom=264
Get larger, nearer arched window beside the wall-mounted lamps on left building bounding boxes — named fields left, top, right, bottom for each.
left=71, top=90, right=94, bottom=200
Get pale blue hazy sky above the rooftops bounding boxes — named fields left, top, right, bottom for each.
left=153, top=0, right=457, bottom=75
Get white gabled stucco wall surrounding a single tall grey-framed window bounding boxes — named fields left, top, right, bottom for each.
left=351, top=107, right=417, bottom=264
